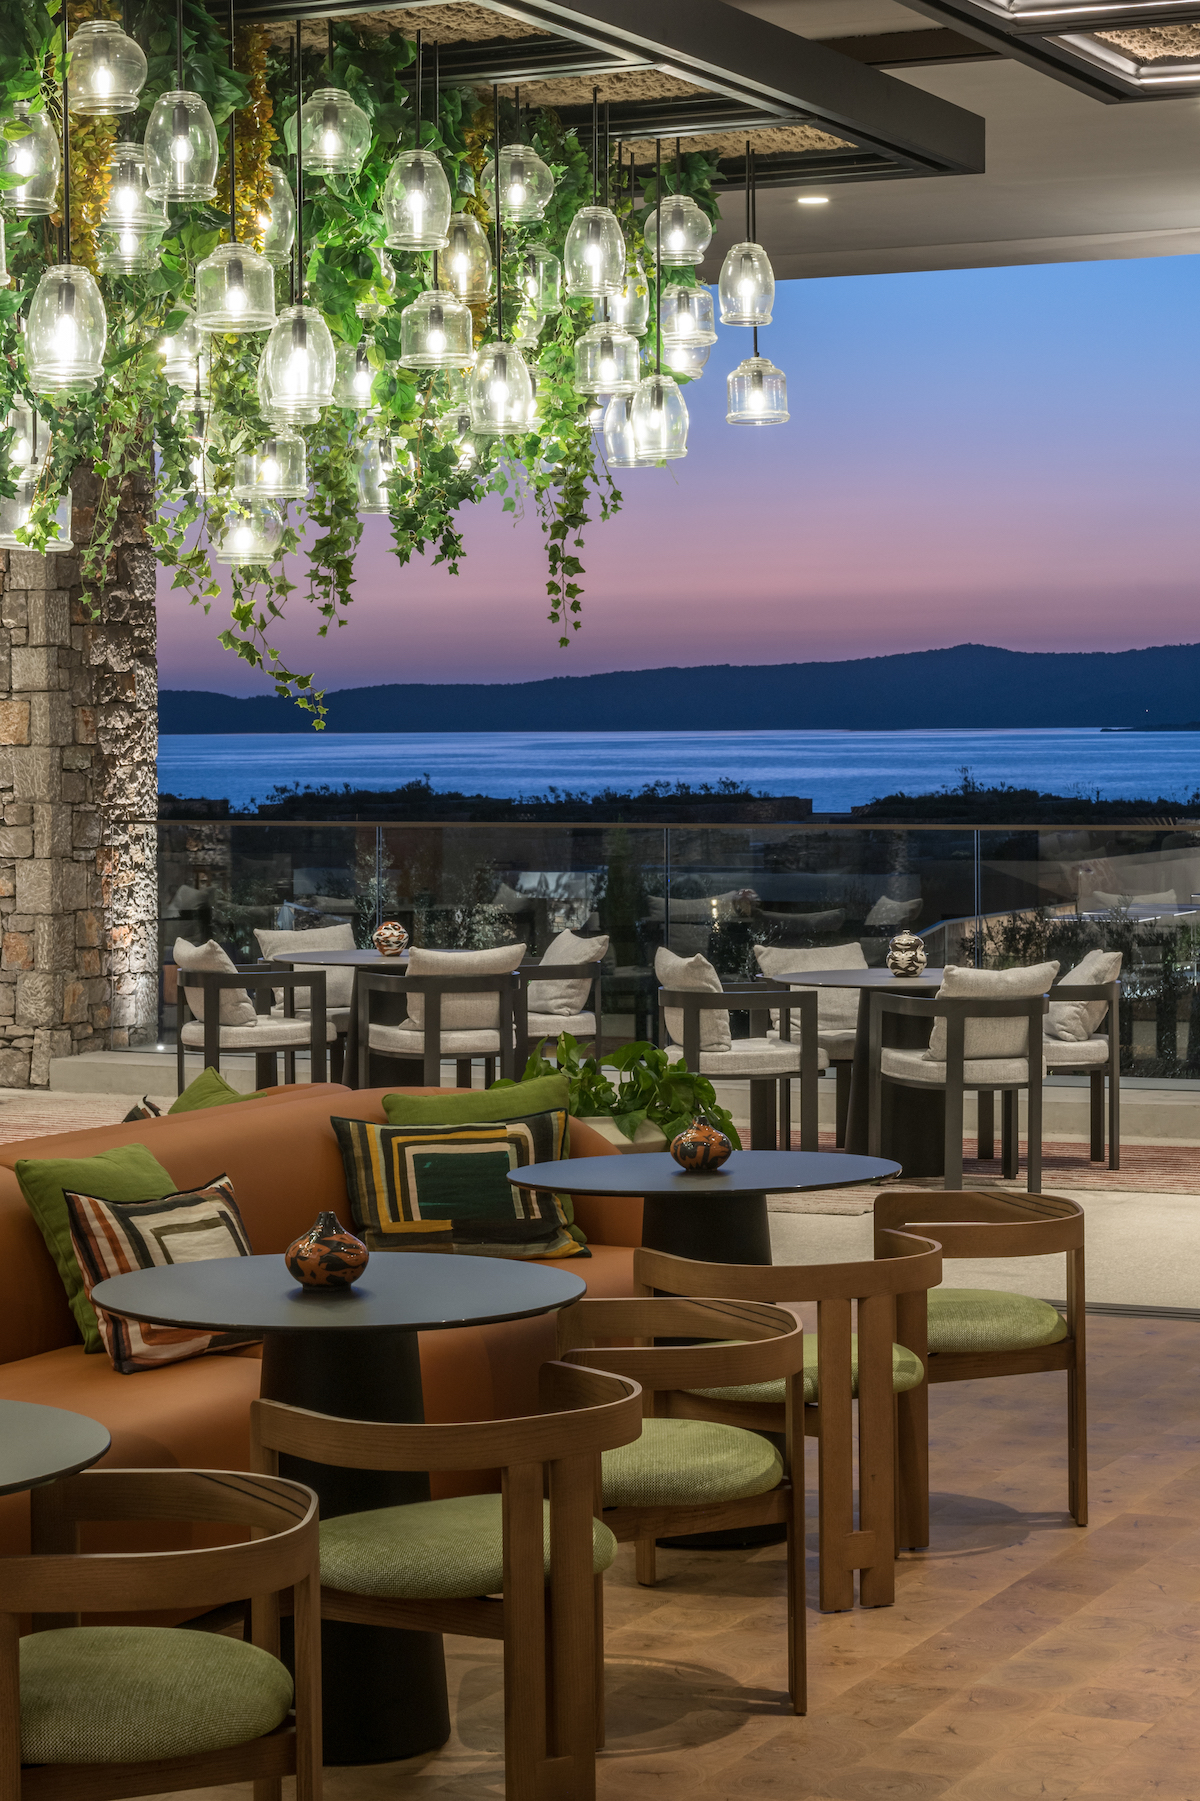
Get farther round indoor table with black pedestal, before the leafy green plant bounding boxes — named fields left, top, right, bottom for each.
left=508, top=1151, right=897, bottom=1263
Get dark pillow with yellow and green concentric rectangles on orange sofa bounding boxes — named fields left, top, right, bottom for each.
left=332, top=1109, right=589, bottom=1257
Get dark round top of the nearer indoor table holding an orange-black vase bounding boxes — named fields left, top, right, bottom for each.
left=92, top=1252, right=586, bottom=1333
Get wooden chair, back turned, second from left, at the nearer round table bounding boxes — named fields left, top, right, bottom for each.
left=250, top=1363, right=641, bottom=1801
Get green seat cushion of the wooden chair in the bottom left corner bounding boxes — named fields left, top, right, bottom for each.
left=22, top=1626, right=292, bottom=1763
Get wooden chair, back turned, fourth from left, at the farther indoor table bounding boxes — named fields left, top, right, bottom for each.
left=634, top=1232, right=942, bottom=1614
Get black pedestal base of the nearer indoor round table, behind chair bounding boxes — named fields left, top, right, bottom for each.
left=261, top=1331, right=450, bottom=1765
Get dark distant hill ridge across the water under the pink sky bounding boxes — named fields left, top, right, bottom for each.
left=159, top=645, right=1200, bottom=733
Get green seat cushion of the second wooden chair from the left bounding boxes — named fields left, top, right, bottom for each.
left=321, top=1495, right=616, bottom=1601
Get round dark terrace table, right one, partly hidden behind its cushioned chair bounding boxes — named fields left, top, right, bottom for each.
left=771, top=969, right=946, bottom=1178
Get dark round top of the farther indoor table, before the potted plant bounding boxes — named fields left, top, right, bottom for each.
left=508, top=1151, right=899, bottom=1199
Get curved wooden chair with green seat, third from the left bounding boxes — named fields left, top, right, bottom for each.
left=557, top=1299, right=807, bottom=1713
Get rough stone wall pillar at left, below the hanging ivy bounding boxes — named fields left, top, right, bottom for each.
left=0, top=475, right=159, bottom=1088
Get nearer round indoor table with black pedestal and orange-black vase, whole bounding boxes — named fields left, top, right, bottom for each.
left=92, top=1252, right=586, bottom=1763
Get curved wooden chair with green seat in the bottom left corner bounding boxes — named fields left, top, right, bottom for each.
left=0, top=1470, right=321, bottom=1801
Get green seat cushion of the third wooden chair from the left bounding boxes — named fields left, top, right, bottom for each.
left=600, top=1419, right=784, bottom=1507
